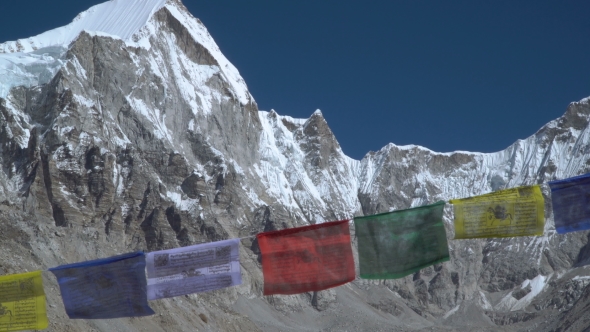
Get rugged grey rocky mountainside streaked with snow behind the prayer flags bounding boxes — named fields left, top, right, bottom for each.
left=0, top=0, right=590, bottom=331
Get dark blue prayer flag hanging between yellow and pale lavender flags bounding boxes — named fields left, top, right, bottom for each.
left=49, top=251, right=154, bottom=319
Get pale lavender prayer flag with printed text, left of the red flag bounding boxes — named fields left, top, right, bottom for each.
left=146, top=239, right=242, bottom=300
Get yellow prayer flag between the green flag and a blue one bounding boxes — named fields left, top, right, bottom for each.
left=450, top=186, right=545, bottom=239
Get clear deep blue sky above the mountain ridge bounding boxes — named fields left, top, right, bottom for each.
left=0, top=0, right=590, bottom=159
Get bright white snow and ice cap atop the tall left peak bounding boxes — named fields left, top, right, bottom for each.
left=0, top=0, right=254, bottom=105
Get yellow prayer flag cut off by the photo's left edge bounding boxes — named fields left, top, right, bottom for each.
left=0, top=271, right=48, bottom=332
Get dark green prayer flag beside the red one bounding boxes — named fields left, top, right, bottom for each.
left=354, top=201, right=449, bottom=279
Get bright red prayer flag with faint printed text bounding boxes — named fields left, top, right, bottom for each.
left=256, top=220, right=355, bottom=295
